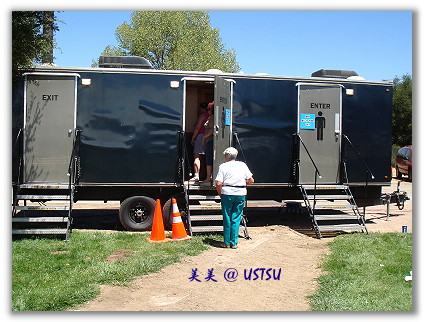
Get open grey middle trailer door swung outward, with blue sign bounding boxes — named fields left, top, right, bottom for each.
left=213, top=76, right=235, bottom=181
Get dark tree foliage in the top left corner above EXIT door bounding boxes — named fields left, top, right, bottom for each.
left=12, top=11, right=59, bottom=75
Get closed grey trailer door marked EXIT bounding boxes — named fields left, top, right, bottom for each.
left=23, top=73, right=78, bottom=184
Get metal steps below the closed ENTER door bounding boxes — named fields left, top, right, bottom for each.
left=299, top=184, right=368, bottom=238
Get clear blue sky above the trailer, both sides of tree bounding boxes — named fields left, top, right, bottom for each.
left=55, top=11, right=413, bottom=81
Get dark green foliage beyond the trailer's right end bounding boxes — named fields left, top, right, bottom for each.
left=392, top=74, right=412, bottom=146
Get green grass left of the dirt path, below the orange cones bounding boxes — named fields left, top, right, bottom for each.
left=12, top=231, right=215, bottom=311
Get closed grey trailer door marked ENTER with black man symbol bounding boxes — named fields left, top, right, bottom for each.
left=297, top=83, right=342, bottom=184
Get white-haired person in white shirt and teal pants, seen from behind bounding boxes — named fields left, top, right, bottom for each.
left=215, top=147, right=255, bottom=248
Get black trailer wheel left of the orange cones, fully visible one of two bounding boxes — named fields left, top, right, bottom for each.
left=119, top=196, right=156, bottom=231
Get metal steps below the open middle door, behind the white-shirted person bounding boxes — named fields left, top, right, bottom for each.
left=186, top=184, right=250, bottom=238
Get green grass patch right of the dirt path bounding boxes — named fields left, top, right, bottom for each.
left=310, top=233, right=412, bottom=311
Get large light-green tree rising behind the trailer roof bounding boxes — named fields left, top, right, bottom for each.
left=103, top=11, right=240, bottom=72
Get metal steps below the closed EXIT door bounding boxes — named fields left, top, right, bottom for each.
left=12, top=184, right=72, bottom=240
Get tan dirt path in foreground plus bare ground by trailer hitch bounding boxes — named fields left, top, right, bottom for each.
left=71, top=180, right=412, bottom=311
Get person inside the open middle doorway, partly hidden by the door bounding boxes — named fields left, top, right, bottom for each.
left=190, top=103, right=209, bottom=182
